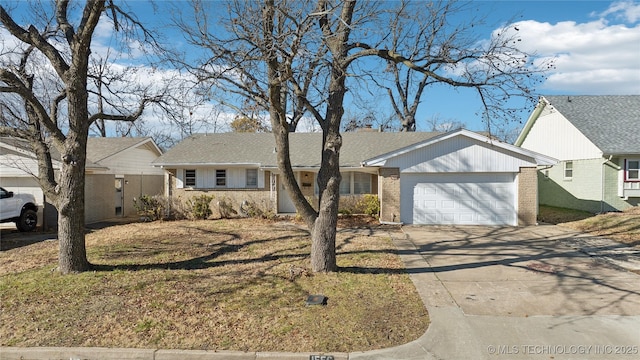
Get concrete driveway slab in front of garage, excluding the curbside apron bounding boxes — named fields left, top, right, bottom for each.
left=405, top=225, right=640, bottom=316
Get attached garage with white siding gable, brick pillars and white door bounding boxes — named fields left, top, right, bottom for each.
left=362, top=129, right=557, bottom=226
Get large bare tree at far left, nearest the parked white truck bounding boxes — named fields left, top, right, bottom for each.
left=0, top=0, right=165, bottom=274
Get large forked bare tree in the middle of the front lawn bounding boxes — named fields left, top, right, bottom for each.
left=178, top=0, right=552, bottom=272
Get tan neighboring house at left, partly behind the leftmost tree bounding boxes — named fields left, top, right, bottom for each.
left=0, top=137, right=164, bottom=228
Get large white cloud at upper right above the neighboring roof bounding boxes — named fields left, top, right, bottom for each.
left=504, top=15, right=640, bottom=94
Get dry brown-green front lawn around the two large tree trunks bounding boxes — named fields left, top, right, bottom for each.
left=0, top=219, right=429, bottom=352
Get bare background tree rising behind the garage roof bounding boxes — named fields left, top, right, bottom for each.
left=379, top=0, right=550, bottom=131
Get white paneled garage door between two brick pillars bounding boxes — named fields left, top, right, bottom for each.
left=400, top=173, right=517, bottom=225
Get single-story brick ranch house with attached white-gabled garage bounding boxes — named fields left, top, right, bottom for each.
left=153, top=130, right=555, bottom=225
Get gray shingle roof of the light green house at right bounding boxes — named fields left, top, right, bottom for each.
left=544, top=95, right=640, bottom=155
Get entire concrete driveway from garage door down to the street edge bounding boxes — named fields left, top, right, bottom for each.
left=349, top=225, right=640, bottom=360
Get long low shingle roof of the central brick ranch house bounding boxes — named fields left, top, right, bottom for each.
left=153, top=132, right=438, bottom=167
